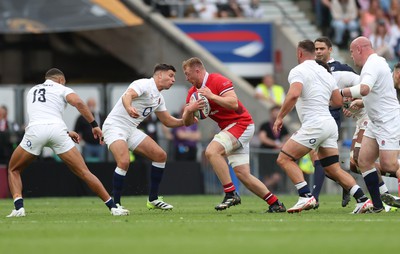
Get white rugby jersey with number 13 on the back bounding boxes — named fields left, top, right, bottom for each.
left=26, top=79, right=74, bottom=126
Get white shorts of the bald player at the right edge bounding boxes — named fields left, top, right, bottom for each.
left=364, top=115, right=400, bottom=150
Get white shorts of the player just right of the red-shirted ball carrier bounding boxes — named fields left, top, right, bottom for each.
left=290, top=117, right=339, bottom=151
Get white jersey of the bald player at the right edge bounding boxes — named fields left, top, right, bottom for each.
left=360, top=54, right=400, bottom=123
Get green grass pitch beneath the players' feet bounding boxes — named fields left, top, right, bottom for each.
left=0, top=195, right=400, bottom=254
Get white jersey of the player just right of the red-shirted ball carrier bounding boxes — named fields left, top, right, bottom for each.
left=288, top=60, right=338, bottom=126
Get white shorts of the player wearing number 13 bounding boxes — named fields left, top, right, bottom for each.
left=20, top=124, right=75, bottom=156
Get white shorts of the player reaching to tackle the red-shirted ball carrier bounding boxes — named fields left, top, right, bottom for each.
left=103, top=123, right=147, bottom=151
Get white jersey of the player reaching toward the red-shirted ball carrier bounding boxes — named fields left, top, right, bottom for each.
left=104, top=78, right=167, bottom=127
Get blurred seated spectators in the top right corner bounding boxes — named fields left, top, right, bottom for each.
left=314, top=0, right=400, bottom=62
